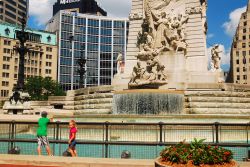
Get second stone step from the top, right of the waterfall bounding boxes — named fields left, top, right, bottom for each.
left=185, top=96, right=250, bottom=103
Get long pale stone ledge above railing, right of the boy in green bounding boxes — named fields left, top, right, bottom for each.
left=54, top=114, right=250, bottom=123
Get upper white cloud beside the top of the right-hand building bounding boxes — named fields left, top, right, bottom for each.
left=222, top=6, right=246, bottom=37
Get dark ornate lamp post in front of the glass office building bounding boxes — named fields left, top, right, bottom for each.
left=77, top=45, right=86, bottom=88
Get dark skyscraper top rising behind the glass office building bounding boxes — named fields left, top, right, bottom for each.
left=53, top=0, right=107, bottom=16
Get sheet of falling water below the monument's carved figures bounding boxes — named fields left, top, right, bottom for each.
left=112, top=90, right=184, bottom=115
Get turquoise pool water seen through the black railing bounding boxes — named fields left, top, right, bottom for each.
left=0, top=134, right=248, bottom=161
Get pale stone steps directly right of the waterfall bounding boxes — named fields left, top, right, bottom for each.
left=184, top=90, right=250, bottom=115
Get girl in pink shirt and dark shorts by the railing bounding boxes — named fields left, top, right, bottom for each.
left=68, top=120, right=77, bottom=157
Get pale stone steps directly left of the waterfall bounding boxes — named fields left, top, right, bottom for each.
left=74, top=86, right=113, bottom=115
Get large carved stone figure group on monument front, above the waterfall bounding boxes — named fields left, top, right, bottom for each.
left=129, top=0, right=189, bottom=87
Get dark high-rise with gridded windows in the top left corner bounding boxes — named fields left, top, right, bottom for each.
left=0, top=0, right=29, bottom=25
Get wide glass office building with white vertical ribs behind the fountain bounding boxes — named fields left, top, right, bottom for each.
left=46, top=11, right=128, bottom=90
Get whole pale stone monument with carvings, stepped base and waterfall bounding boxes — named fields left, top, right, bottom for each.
left=50, top=0, right=250, bottom=119
